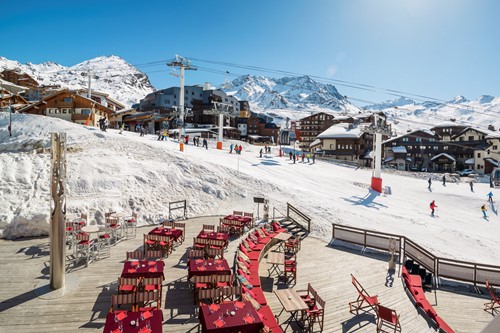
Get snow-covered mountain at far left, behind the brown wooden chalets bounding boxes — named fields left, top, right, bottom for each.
left=0, top=55, right=155, bottom=106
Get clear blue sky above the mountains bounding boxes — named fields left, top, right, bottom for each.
left=0, top=0, right=500, bottom=104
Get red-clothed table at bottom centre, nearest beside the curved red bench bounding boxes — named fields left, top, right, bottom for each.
left=199, top=301, right=264, bottom=333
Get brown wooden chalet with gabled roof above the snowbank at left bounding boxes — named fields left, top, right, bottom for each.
left=19, top=89, right=113, bottom=126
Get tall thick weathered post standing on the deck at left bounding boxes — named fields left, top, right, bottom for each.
left=50, top=133, right=66, bottom=289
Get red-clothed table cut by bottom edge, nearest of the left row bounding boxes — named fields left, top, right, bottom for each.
left=102, top=310, right=163, bottom=333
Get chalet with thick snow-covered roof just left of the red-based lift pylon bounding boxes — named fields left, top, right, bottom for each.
left=308, top=123, right=373, bottom=166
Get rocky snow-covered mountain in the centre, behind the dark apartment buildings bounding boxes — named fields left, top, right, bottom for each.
left=220, top=75, right=359, bottom=119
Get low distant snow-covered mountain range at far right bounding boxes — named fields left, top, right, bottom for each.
left=363, top=95, right=500, bottom=133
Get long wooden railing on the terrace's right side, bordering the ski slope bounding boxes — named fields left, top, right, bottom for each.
left=332, top=223, right=500, bottom=286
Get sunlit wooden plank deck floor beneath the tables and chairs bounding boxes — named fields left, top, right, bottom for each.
left=0, top=217, right=493, bottom=333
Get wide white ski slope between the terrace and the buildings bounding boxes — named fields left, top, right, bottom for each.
left=0, top=113, right=500, bottom=265
